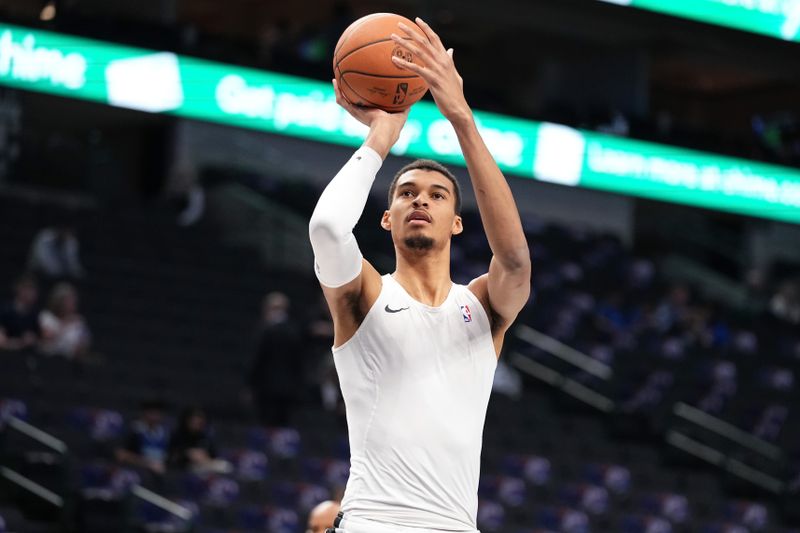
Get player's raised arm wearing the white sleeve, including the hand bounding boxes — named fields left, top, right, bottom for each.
left=308, top=81, right=408, bottom=346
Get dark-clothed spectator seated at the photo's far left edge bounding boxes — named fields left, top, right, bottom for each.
left=0, top=274, right=41, bottom=350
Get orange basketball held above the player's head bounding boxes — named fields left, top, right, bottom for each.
left=333, top=13, right=428, bottom=112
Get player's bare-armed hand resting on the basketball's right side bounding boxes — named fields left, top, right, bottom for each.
left=392, top=17, right=472, bottom=124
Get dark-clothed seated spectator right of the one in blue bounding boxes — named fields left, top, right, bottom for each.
left=167, top=407, right=232, bottom=473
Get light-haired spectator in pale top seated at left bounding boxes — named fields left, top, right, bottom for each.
left=39, top=282, right=91, bottom=359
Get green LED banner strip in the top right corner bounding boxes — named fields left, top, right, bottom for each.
left=600, top=0, right=800, bottom=42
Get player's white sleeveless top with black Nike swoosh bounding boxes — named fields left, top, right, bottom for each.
left=333, top=274, right=497, bottom=531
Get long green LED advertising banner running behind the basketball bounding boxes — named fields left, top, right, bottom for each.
left=0, top=24, right=800, bottom=223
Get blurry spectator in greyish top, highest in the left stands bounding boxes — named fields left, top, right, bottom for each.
left=28, top=225, right=84, bottom=279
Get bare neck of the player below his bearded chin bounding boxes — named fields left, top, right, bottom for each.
left=392, top=244, right=453, bottom=307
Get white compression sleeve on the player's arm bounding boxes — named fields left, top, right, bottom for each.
left=308, top=146, right=383, bottom=288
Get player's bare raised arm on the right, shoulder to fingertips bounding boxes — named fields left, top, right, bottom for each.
left=392, top=18, right=531, bottom=332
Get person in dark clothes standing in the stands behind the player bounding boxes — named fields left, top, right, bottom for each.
left=250, top=292, right=303, bottom=427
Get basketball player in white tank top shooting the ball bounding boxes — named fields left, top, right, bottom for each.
left=309, top=19, right=531, bottom=533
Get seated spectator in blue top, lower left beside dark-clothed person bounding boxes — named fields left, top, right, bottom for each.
left=116, top=401, right=169, bottom=475
